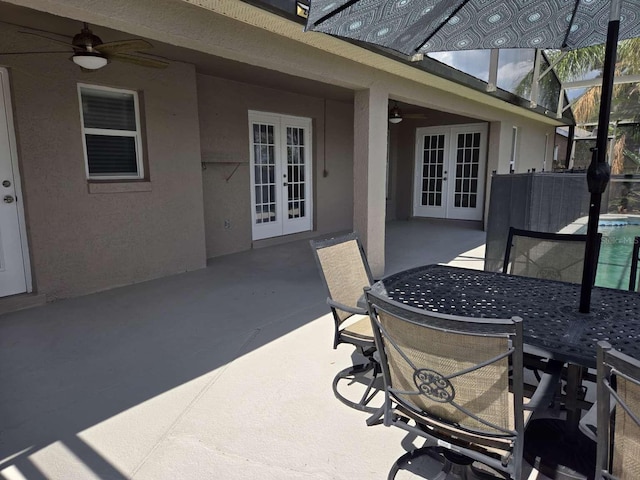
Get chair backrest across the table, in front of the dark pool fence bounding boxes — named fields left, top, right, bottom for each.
left=502, top=227, right=602, bottom=283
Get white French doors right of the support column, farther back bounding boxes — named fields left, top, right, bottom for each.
left=413, top=123, right=487, bottom=220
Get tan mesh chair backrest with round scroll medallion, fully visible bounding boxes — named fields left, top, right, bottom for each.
left=367, top=290, right=524, bottom=451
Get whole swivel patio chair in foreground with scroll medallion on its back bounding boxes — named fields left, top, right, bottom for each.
left=366, top=289, right=557, bottom=480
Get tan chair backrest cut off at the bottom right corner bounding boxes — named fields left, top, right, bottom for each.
left=596, top=342, right=640, bottom=480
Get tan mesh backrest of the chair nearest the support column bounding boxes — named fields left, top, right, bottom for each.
left=311, top=233, right=373, bottom=322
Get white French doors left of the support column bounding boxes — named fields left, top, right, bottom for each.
left=249, top=112, right=312, bottom=240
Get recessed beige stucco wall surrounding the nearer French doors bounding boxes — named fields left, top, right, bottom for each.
left=197, top=75, right=353, bottom=257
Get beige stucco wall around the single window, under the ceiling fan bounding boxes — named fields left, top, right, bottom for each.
left=0, top=25, right=205, bottom=299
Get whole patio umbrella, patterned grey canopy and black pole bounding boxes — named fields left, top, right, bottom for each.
left=306, top=0, right=640, bottom=313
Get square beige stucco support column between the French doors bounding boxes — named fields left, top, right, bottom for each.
left=353, top=86, right=389, bottom=278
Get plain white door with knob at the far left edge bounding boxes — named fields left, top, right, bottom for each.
left=0, top=68, right=29, bottom=297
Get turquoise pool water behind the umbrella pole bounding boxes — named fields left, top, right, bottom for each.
left=596, top=222, right=640, bottom=290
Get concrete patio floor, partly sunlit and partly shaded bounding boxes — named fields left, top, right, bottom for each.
left=0, top=221, right=556, bottom=480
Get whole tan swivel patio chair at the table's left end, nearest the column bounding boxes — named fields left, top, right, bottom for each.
left=311, top=233, right=380, bottom=412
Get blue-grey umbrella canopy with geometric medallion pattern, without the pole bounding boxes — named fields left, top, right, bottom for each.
left=307, top=0, right=640, bottom=56
